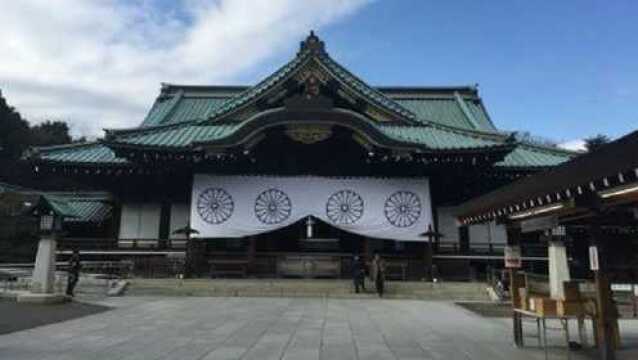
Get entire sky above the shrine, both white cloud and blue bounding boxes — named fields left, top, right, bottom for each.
left=0, top=0, right=638, bottom=145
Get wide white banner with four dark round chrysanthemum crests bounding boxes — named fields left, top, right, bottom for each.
left=191, top=174, right=432, bottom=241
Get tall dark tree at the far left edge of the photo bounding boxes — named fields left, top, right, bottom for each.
left=0, top=91, right=31, bottom=160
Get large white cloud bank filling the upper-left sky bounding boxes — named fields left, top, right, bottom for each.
left=0, top=0, right=368, bottom=136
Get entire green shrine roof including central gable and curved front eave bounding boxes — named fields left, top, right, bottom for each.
left=30, top=33, right=573, bottom=168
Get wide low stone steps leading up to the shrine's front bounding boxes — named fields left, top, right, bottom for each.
left=126, top=279, right=496, bottom=301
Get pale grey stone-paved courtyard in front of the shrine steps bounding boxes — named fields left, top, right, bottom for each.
left=0, top=297, right=631, bottom=360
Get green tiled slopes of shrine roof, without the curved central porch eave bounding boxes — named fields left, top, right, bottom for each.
left=27, top=35, right=571, bottom=168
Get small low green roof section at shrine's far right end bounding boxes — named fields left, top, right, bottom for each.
left=496, top=144, right=576, bottom=168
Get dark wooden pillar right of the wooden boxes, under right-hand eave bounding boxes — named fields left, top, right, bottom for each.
left=590, top=222, right=619, bottom=360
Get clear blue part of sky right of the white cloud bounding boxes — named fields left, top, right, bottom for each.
left=246, top=0, right=638, bottom=141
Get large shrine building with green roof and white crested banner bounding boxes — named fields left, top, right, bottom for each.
left=26, top=33, right=575, bottom=279
